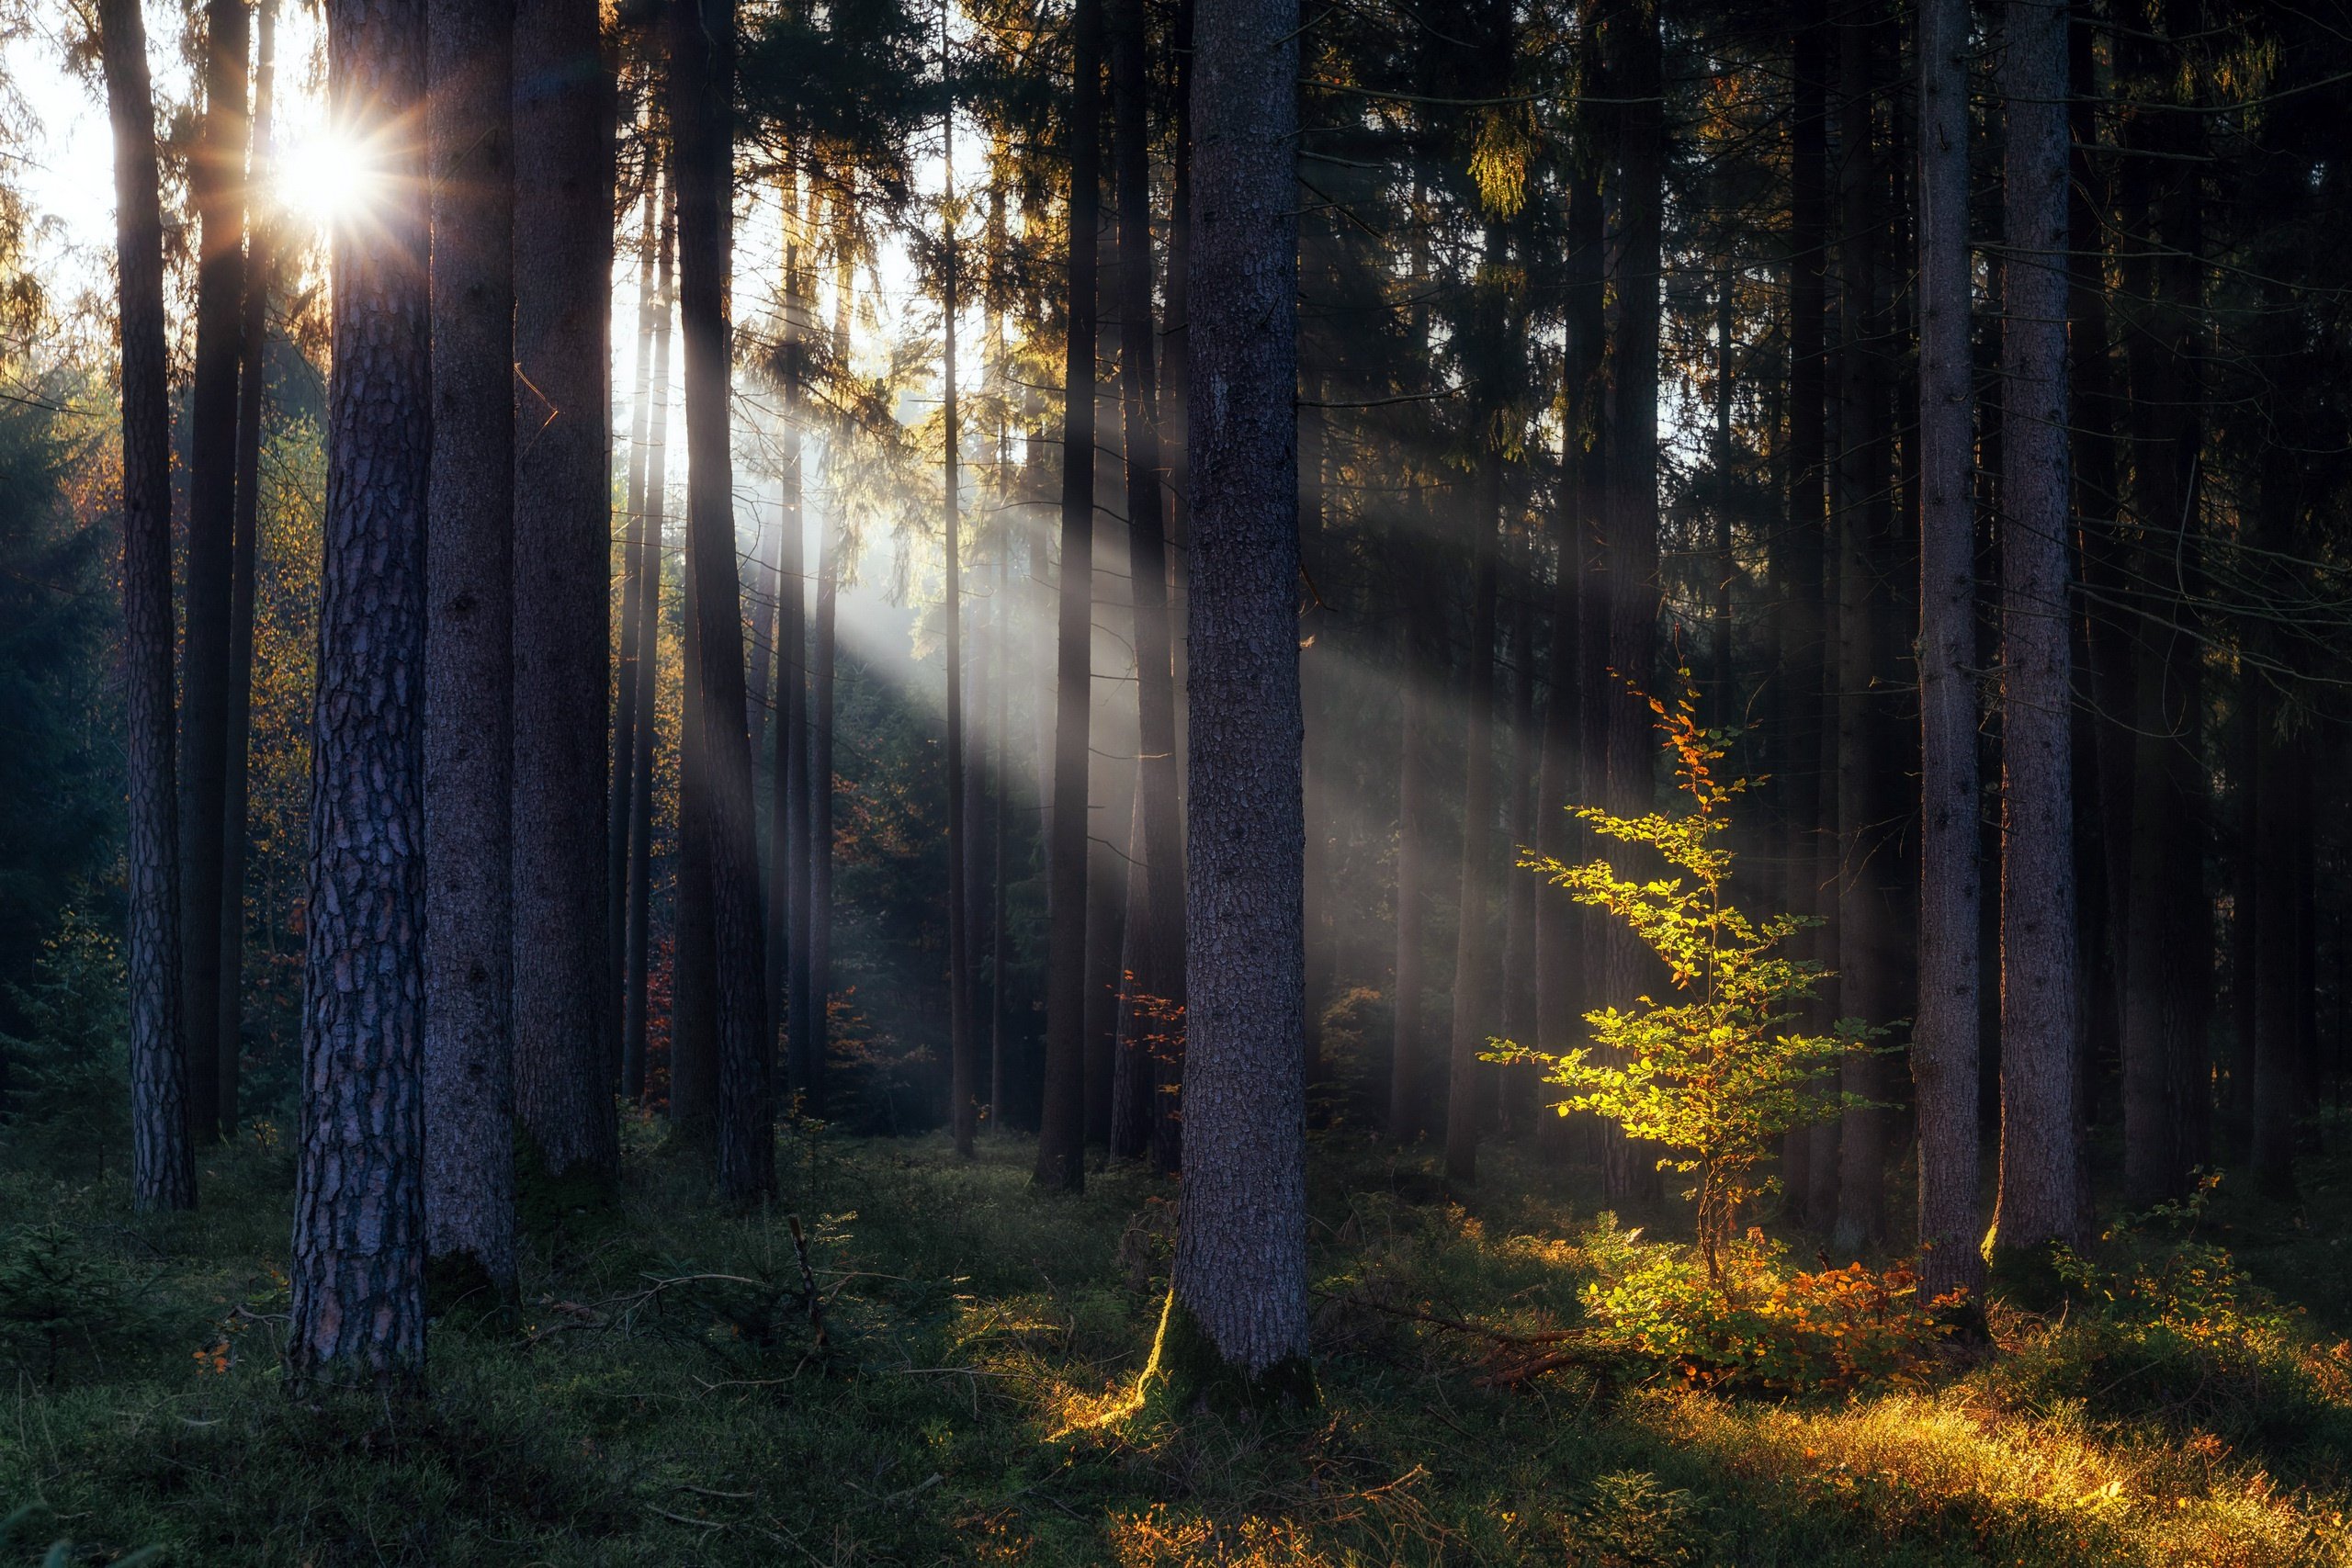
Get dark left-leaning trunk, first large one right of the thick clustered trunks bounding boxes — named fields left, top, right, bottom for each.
left=671, top=0, right=771, bottom=1203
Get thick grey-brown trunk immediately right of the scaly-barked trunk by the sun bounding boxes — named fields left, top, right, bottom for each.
left=424, top=0, right=515, bottom=1298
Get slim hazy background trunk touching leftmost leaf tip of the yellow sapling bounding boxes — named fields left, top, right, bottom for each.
left=1446, top=453, right=1503, bottom=1185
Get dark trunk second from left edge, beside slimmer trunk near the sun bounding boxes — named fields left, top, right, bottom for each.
left=179, top=0, right=252, bottom=1140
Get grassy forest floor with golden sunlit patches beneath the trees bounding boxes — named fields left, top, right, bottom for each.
left=0, top=1126, right=2352, bottom=1568
